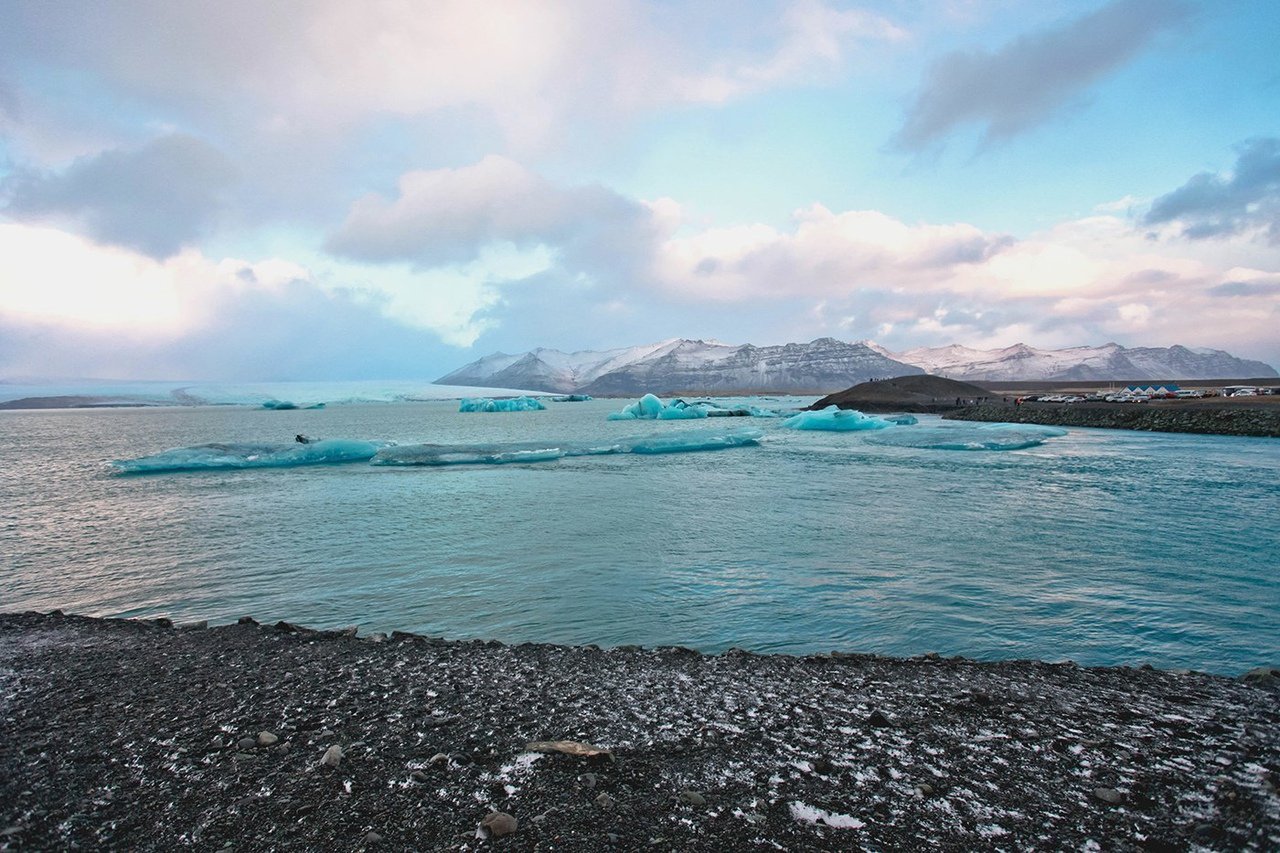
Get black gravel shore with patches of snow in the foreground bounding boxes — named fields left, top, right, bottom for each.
left=0, top=612, right=1280, bottom=850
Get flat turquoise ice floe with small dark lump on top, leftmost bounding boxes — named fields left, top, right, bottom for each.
left=111, top=438, right=383, bottom=474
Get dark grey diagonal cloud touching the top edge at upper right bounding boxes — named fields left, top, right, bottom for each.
left=895, top=0, right=1188, bottom=151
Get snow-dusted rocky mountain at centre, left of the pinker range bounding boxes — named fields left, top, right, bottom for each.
left=436, top=338, right=922, bottom=394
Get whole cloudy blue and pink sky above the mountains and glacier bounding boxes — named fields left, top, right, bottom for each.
left=0, top=0, right=1280, bottom=380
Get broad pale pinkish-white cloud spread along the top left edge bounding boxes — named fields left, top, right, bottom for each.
left=0, top=0, right=902, bottom=147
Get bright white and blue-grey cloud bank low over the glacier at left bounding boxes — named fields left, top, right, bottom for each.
left=0, top=223, right=485, bottom=379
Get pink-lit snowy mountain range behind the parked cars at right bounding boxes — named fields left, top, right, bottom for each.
left=893, top=343, right=1276, bottom=382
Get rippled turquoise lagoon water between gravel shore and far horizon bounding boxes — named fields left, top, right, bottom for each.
left=0, top=401, right=1280, bottom=672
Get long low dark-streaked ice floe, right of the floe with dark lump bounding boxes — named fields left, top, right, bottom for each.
left=372, top=429, right=764, bottom=466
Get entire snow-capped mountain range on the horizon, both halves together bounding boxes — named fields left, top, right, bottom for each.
left=436, top=338, right=1277, bottom=394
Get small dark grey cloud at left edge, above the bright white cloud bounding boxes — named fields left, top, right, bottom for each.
left=0, top=133, right=237, bottom=257
